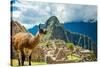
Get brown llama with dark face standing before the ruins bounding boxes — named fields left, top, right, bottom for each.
left=12, top=26, right=46, bottom=66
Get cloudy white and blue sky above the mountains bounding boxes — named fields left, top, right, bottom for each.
left=11, top=0, right=97, bottom=29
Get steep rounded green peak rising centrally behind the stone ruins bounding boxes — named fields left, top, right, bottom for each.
left=45, top=16, right=67, bottom=41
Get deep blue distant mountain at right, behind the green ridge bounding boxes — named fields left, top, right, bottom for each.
left=63, top=22, right=97, bottom=42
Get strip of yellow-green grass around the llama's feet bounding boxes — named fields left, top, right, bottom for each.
left=11, top=59, right=47, bottom=67
